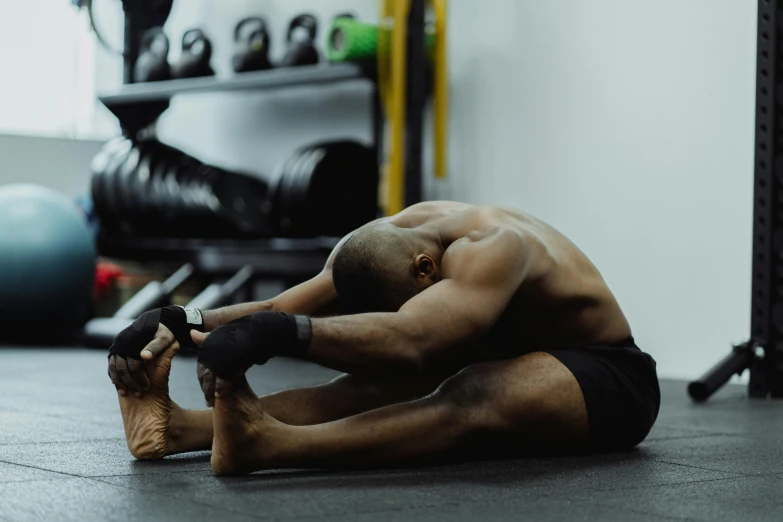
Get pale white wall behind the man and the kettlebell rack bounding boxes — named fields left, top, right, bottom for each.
left=92, top=0, right=756, bottom=377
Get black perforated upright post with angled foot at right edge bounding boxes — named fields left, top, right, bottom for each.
left=688, top=0, right=783, bottom=402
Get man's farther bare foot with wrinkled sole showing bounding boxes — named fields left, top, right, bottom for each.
left=119, top=344, right=189, bottom=460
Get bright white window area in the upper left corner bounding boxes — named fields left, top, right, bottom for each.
left=0, top=0, right=108, bottom=138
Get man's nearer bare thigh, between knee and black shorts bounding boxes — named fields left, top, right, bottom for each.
left=434, top=352, right=589, bottom=454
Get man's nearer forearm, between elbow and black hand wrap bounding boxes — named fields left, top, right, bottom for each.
left=308, top=313, right=422, bottom=375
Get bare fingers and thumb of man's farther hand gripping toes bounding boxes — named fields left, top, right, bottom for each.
left=109, top=318, right=179, bottom=397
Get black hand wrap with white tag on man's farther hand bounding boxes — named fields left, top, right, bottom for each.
left=109, top=306, right=204, bottom=359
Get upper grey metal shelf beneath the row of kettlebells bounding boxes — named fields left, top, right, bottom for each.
left=98, top=63, right=373, bottom=130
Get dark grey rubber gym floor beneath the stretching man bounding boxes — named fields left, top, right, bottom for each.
left=0, top=348, right=783, bottom=522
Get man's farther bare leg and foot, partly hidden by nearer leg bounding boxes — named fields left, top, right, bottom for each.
left=119, top=348, right=445, bottom=460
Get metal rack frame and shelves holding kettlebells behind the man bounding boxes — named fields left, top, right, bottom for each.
left=98, top=0, right=429, bottom=280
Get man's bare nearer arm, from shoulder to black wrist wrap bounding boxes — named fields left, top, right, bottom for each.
left=308, top=230, right=533, bottom=374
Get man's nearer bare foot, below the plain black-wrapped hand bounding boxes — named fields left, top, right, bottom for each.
left=211, top=374, right=283, bottom=476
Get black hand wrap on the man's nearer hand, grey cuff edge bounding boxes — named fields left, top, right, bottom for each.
left=198, top=312, right=312, bottom=377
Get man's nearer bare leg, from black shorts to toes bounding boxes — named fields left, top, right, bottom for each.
left=212, top=352, right=588, bottom=475
